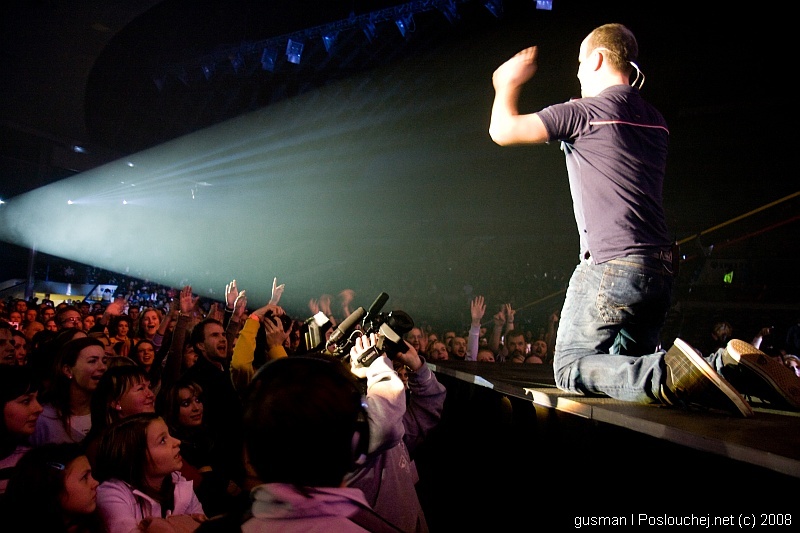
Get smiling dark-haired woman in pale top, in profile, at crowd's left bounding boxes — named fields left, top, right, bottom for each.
left=31, top=334, right=106, bottom=446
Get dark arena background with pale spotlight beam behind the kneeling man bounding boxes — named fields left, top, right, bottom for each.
left=0, top=0, right=798, bottom=334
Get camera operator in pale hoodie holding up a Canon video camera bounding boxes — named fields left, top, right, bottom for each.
left=345, top=333, right=447, bottom=532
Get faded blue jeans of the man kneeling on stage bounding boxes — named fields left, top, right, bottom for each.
left=553, top=255, right=674, bottom=403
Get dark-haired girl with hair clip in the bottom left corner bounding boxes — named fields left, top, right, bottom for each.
left=2, top=443, right=101, bottom=533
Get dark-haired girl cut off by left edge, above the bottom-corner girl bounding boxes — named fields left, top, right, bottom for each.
left=0, top=365, right=42, bottom=494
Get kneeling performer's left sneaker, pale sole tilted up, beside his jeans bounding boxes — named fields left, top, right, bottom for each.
left=661, top=339, right=753, bottom=418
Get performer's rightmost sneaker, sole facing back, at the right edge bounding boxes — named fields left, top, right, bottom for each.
left=723, top=339, right=800, bottom=409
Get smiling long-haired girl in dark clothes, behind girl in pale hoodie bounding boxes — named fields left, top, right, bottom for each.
left=162, top=378, right=248, bottom=516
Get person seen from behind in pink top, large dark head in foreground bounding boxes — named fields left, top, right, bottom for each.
left=199, top=354, right=402, bottom=533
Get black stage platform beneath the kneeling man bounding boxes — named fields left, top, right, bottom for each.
left=415, top=361, right=800, bottom=531
